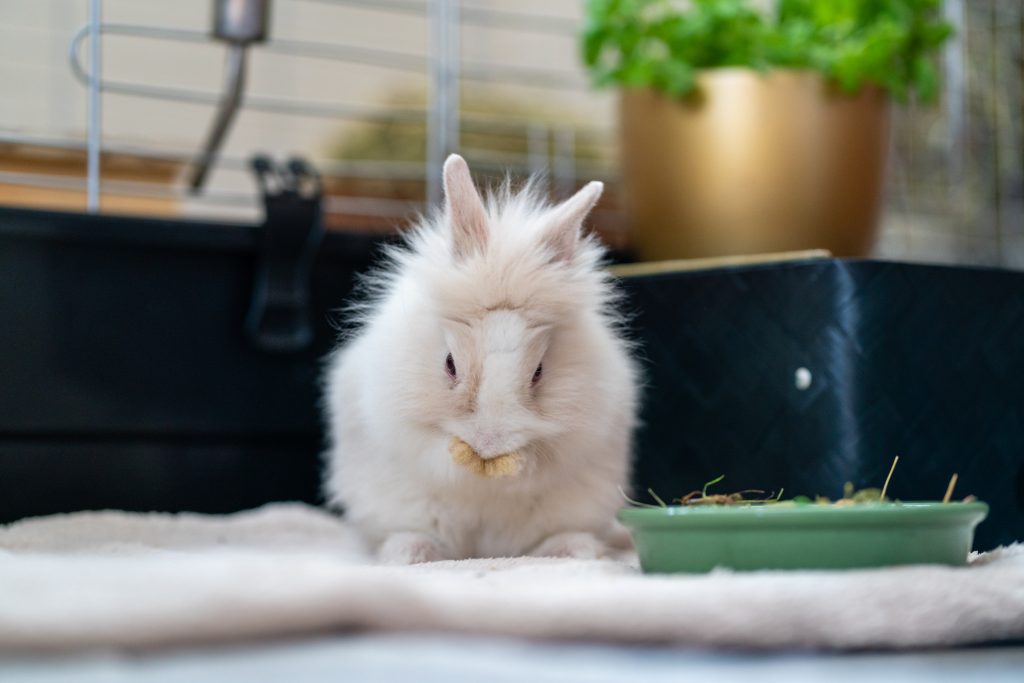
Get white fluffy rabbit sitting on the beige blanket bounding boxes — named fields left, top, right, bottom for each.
left=325, top=155, right=637, bottom=563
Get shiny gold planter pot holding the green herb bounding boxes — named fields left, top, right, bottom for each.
left=622, top=69, right=889, bottom=260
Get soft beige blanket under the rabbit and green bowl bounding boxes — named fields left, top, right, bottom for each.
left=0, top=505, right=1024, bottom=651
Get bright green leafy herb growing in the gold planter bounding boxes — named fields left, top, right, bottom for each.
left=582, top=0, right=952, bottom=101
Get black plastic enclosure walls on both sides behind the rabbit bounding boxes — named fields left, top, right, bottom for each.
left=0, top=209, right=1024, bottom=549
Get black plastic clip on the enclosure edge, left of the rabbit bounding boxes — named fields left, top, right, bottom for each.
left=246, top=156, right=324, bottom=352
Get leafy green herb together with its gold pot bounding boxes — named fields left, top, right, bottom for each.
left=583, top=0, right=951, bottom=260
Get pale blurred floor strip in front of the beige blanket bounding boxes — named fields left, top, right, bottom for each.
left=0, top=635, right=1024, bottom=683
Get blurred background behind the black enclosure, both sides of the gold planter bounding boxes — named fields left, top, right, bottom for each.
left=0, top=0, right=1024, bottom=268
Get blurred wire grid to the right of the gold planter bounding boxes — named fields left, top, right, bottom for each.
left=878, top=0, right=1024, bottom=269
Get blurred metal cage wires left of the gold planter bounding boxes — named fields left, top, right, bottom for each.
left=0, top=0, right=612, bottom=216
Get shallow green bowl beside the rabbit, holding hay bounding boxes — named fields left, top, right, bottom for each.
left=618, top=502, right=988, bottom=572
